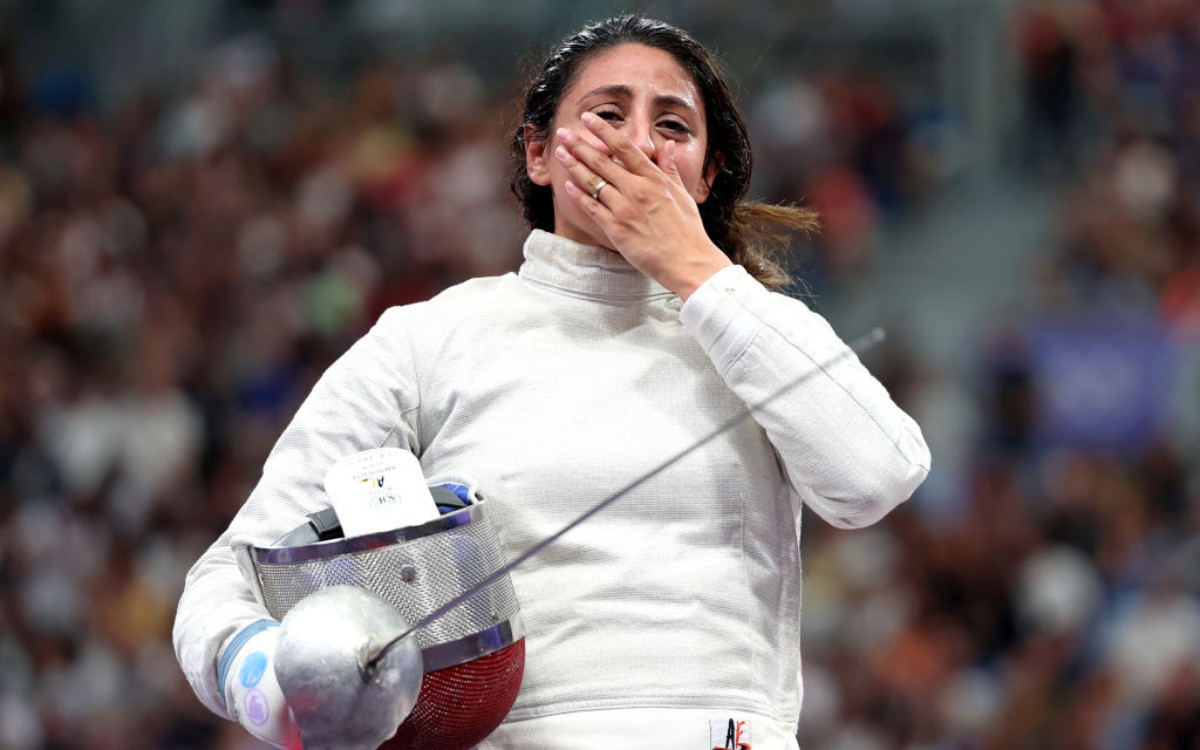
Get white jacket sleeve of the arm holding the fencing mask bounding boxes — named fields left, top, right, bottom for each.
left=173, top=308, right=420, bottom=718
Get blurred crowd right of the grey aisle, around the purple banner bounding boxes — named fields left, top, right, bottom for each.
left=802, top=0, right=1200, bottom=750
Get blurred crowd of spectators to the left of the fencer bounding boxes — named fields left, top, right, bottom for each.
left=0, top=27, right=535, bottom=749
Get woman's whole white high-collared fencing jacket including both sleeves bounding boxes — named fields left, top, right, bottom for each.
left=174, top=232, right=929, bottom=749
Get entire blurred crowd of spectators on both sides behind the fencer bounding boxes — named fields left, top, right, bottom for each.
left=0, top=0, right=1200, bottom=750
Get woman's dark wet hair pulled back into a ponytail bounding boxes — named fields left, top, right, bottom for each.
left=510, top=16, right=817, bottom=287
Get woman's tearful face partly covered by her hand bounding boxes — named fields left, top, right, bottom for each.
left=526, top=43, right=716, bottom=245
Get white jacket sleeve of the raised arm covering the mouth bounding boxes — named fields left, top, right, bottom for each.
left=680, top=266, right=930, bottom=528
